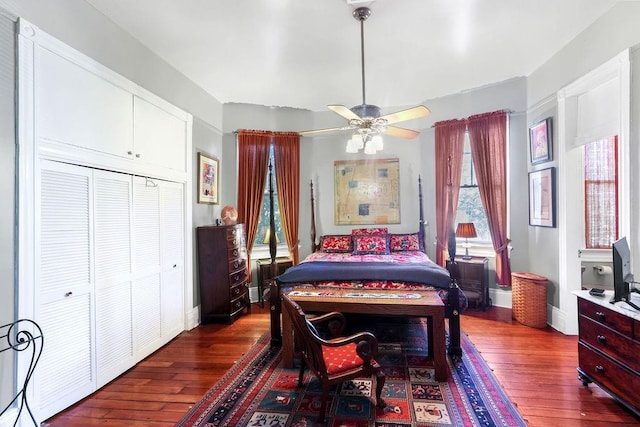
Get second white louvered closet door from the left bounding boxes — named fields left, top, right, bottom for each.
left=93, top=170, right=135, bottom=387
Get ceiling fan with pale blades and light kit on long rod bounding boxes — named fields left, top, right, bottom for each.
left=300, top=7, right=430, bottom=147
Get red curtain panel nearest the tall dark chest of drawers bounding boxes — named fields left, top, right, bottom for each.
left=238, top=130, right=272, bottom=280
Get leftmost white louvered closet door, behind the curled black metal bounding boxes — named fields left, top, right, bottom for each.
left=33, top=161, right=95, bottom=419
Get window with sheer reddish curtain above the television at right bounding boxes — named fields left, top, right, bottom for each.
left=584, top=135, right=618, bottom=249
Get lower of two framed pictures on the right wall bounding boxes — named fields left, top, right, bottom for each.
left=529, top=168, right=556, bottom=227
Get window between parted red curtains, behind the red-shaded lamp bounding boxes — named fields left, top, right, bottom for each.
left=456, top=132, right=491, bottom=242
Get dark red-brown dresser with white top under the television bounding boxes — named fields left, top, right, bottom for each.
left=575, top=291, right=640, bottom=415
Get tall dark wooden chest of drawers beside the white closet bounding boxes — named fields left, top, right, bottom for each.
left=197, top=224, right=251, bottom=323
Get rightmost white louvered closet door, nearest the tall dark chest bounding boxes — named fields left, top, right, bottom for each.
left=160, top=182, right=184, bottom=341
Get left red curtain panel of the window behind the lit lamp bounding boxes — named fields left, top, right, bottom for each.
left=434, top=120, right=466, bottom=265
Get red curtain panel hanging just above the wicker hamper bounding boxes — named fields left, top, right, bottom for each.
left=467, top=111, right=511, bottom=286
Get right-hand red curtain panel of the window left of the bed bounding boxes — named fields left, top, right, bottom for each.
left=273, top=132, right=300, bottom=265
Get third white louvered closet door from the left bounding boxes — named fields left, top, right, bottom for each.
left=132, top=176, right=162, bottom=360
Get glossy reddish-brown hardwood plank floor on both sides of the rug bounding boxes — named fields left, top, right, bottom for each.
left=42, top=304, right=640, bottom=427
